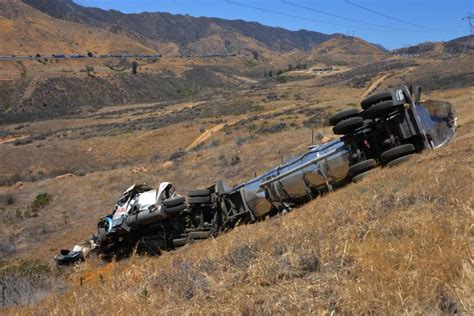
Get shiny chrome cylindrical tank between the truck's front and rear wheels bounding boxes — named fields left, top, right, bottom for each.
left=236, top=140, right=349, bottom=217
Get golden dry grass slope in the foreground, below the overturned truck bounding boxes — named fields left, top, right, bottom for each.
left=2, top=88, right=474, bottom=314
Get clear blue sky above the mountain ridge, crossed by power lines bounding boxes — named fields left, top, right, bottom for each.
left=74, top=0, right=474, bottom=49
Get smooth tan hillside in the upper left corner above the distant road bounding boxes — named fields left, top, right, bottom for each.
left=0, top=0, right=154, bottom=55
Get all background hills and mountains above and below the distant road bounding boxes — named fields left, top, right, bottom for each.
left=0, top=0, right=387, bottom=117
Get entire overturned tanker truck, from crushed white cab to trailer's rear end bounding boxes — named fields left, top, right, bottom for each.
left=54, top=86, right=456, bottom=264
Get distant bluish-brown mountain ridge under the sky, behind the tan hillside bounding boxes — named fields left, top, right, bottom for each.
left=23, top=0, right=366, bottom=54
